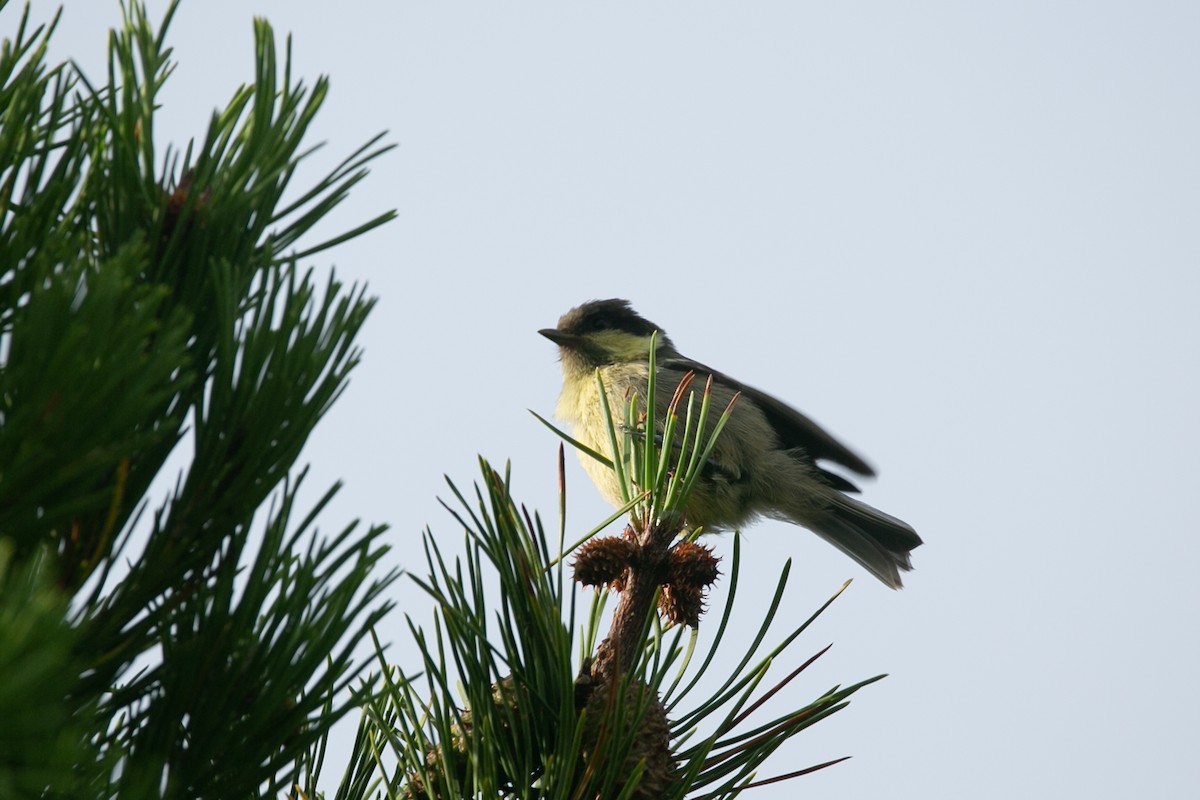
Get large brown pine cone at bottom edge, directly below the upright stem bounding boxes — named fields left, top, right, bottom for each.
left=583, top=681, right=679, bottom=800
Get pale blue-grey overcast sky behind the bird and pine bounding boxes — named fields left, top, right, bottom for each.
left=44, top=0, right=1200, bottom=800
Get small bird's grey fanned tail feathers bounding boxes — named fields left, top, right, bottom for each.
left=797, top=491, right=922, bottom=589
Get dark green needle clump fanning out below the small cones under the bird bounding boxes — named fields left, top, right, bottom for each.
left=328, top=462, right=878, bottom=800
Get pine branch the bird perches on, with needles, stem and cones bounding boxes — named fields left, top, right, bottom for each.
left=337, top=345, right=882, bottom=800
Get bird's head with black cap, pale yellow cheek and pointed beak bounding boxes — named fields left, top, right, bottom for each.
left=538, top=299, right=674, bottom=372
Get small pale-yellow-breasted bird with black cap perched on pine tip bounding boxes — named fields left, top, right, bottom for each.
left=538, top=299, right=922, bottom=589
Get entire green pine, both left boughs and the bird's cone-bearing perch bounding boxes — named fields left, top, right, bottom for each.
left=0, top=0, right=892, bottom=800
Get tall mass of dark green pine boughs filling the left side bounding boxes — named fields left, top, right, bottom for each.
left=0, top=0, right=395, bottom=798
